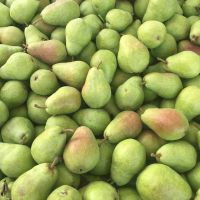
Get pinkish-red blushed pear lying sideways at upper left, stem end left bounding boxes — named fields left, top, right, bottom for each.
left=27, top=40, right=67, bottom=64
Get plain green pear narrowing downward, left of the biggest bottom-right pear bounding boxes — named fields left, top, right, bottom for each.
left=111, top=139, right=146, bottom=186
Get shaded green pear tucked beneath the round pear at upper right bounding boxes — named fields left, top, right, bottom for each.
left=151, top=33, right=177, bottom=59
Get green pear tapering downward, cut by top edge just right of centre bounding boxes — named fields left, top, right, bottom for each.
left=92, top=0, right=116, bottom=18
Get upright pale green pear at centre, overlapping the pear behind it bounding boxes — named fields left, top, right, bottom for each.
left=82, top=67, right=111, bottom=108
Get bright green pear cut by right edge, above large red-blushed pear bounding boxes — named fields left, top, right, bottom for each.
left=175, top=86, right=200, bottom=121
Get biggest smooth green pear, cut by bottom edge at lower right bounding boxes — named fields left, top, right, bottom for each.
left=136, top=164, right=192, bottom=200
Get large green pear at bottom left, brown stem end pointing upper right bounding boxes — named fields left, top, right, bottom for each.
left=11, top=163, right=58, bottom=200
